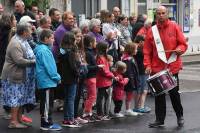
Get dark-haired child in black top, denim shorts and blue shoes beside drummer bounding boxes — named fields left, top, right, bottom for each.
left=133, top=35, right=151, bottom=113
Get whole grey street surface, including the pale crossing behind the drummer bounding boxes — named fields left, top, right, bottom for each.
left=0, top=55, right=200, bottom=133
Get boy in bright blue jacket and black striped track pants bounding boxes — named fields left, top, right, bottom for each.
left=34, top=30, right=62, bottom=130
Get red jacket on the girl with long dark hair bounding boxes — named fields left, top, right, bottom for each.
left=97, top=56, right=114, bottom=88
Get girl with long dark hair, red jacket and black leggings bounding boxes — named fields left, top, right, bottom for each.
left=96, top=42, right=114, bottom=120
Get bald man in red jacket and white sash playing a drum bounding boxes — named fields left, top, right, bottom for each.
left=143, top=6, right=187, bottom=128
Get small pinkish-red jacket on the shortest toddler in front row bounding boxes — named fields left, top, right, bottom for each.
left=113, top=72, right=128, bottom=100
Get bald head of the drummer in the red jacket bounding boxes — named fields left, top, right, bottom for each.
left=156, top=6, right=168, bottom=23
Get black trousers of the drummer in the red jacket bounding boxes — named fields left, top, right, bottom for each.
left=155, top=74, right=183, bottom=122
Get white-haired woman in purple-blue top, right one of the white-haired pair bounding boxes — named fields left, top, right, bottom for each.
left=88, top=18, right=104, bottom=43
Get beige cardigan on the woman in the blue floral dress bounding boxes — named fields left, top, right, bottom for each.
left=1, top=37, right=35, bottom=83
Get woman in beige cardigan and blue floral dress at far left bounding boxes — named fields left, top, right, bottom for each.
left=1, top=23, right=35, bottom=128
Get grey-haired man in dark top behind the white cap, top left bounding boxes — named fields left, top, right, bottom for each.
left=14, top=0, right=35, bottom=22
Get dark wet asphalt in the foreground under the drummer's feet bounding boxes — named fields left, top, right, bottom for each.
left=0, top=92, right=200, bottom=133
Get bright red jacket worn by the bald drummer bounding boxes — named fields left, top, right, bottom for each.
left=143, top=20, right=187, bottom=74
